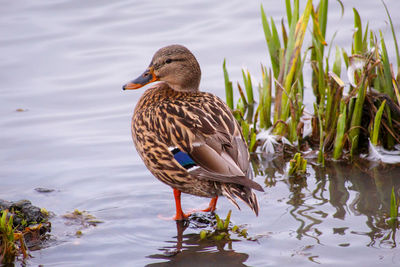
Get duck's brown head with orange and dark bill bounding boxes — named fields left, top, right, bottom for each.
left=122, top=45, right=201, bottom=91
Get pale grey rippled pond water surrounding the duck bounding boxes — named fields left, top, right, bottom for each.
left=0, top=0, right=400, bottom=266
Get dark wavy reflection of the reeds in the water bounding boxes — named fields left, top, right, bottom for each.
left=253, top=156, right=400, bottom=247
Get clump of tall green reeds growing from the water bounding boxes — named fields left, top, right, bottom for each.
left=223, top=0, right=400, bottom=165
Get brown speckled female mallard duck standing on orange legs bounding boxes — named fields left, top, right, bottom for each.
left=123, top=45, right=264, bottom=220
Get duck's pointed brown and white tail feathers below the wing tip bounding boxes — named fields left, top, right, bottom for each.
left=221, top=184, right=258, bottom=216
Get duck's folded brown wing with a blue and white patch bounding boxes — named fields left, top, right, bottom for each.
left=162, top=93, right=263, bottom=191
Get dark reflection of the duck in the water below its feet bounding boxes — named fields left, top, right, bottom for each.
left=146, top=221, right=249, bottom=267
